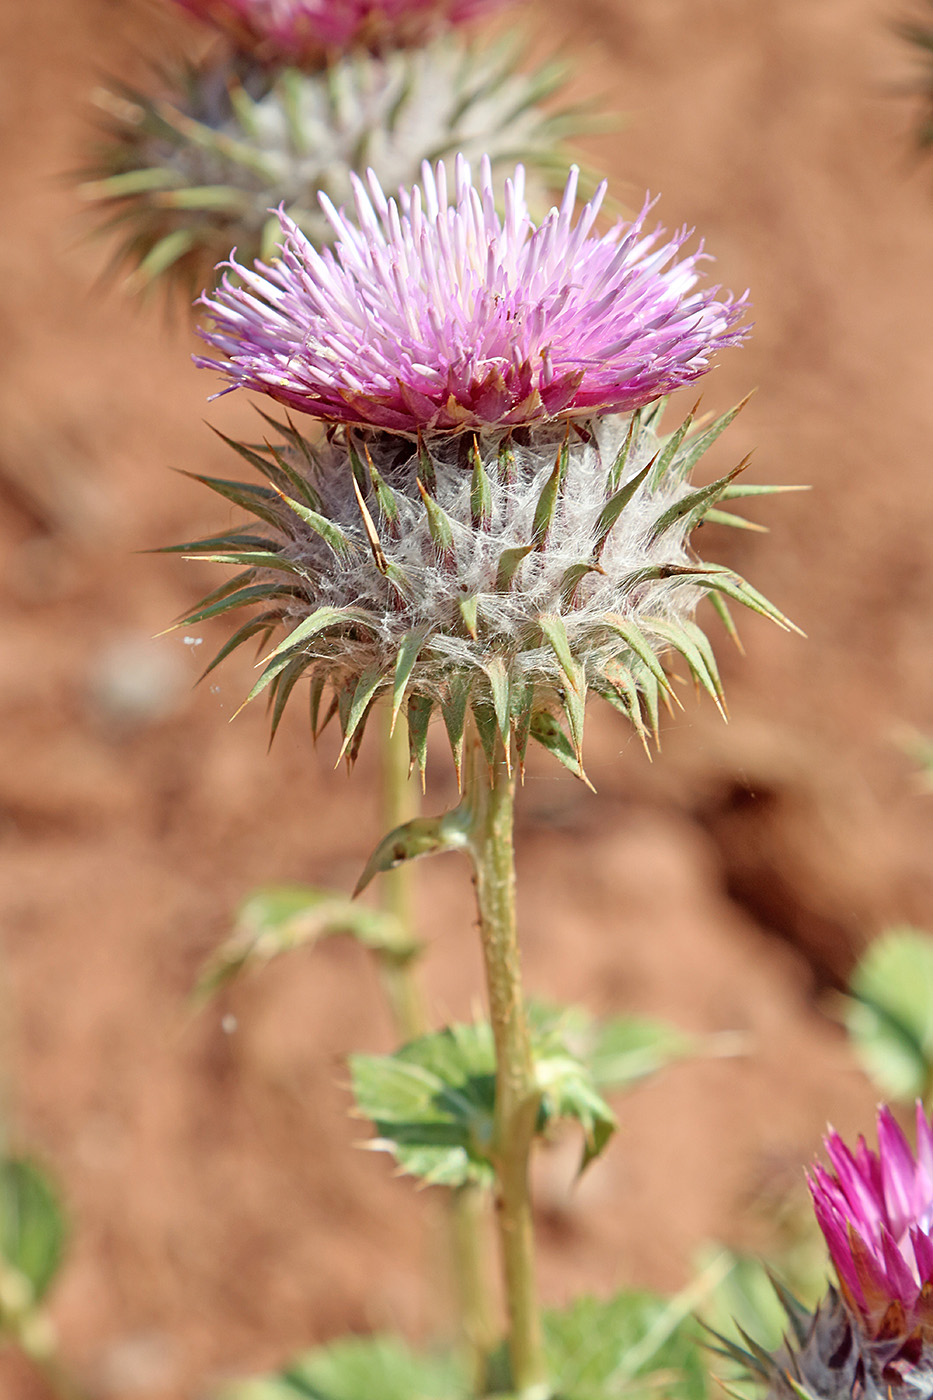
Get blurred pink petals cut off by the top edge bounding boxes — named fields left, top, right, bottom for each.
left=170, top=0, right=503, bottom=63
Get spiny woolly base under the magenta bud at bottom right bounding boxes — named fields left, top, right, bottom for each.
left=714, top=1285, right=933, bottom=1400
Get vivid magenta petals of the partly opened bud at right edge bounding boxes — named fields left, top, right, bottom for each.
left=810, top=1103, right=933, bottom=1329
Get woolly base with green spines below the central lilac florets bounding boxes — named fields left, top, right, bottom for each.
left=175, top=403, right=789, bottom=776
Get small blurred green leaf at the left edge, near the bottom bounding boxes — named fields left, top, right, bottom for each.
left=0, top=1158, right=66, bottom=1303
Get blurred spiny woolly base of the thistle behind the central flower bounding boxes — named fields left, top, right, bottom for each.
left=83, top=35, right=584, bottom=295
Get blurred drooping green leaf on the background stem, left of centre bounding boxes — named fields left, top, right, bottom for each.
left=195, top=885, right=420, bottom=1001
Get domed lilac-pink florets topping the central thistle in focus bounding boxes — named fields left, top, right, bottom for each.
left=196, top=157, right=745, bottom=434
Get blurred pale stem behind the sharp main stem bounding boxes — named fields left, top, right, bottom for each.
left=380, top=705, right=496, bottom=1393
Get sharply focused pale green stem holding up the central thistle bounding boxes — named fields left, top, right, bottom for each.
left=465, top=736, right=545, bottom=1397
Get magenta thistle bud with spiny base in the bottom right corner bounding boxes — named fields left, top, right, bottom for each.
left=720, top=1103, right=933, bottom=1400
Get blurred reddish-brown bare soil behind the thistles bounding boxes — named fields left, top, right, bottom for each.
left=0, top=0, right=933, bottom=1400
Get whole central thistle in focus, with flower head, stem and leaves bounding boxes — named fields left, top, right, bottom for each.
left=167, top=157, right=789, bottom=1400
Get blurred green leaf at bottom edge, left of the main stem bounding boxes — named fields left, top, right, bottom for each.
left=219, top=1336, right=471, bottom=1400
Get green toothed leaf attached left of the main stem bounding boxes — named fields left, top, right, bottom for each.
left=350, top=1022, right=496, bottom=1186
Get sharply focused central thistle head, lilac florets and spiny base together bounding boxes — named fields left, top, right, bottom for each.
left=168, top=160, right=786, bottom=776
